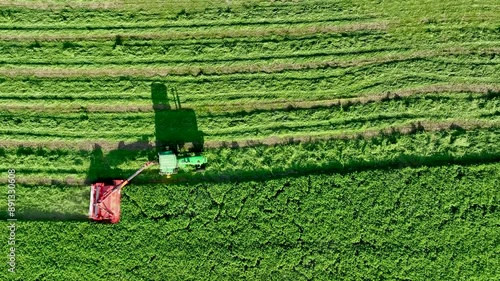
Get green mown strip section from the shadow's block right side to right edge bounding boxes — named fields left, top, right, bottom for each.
left=202, top=98, right=499, bottom=140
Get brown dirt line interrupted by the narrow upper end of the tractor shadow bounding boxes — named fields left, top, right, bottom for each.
left=0, top=83, right=500, bottom=114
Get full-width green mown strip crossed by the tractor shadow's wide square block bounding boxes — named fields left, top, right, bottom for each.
left=0, top=91, right=498, bottom=144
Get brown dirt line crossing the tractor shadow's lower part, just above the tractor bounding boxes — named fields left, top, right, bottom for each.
left=0, top=120, right=500, bottom=151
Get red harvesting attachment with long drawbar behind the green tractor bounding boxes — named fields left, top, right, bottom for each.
left=89, top=162, right=156, bottom=223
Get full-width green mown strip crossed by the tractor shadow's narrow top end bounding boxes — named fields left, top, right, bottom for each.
left=0, top=59, right=496, bottom=108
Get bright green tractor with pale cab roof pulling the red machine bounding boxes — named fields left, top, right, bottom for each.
left=158, top=150, right=207, bottom=178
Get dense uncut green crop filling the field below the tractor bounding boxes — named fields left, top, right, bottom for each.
left=0, top=164, right=499, bottom=280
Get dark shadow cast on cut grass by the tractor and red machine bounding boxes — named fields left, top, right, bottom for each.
left=85, top=82, right=204, bottom=184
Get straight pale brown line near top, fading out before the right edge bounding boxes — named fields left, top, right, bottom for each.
left=0, top=21, right=389, bottom=42
